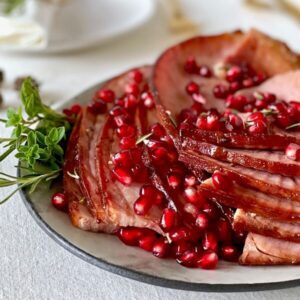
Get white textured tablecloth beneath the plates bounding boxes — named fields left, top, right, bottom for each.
left=0, top=0, right=300, bottom=300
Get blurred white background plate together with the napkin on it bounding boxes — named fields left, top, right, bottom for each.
left=0, top=0, right=156, bottom=52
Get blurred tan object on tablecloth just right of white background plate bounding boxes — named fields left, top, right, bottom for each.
left=166, top=0, right=199, bottom=33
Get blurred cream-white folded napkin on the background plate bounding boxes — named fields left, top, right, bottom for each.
left=0, top=0, right=65, bottom=49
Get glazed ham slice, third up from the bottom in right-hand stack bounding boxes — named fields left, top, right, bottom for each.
left=199, top=178, right=300, bottom=222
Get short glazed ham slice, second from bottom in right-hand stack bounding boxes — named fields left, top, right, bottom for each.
left=233, top=209, right=300, bottom=243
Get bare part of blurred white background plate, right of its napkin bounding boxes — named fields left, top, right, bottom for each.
left=1, top=0, right=156, bottom=53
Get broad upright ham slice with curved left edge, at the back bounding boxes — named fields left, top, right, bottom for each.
left=153, top=32, right=243, bottom=115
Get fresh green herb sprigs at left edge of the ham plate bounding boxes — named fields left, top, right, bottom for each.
left=0, top=78, right=71, bottom=204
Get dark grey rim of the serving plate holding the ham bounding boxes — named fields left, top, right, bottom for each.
left=17, top=76, right=300, bottom=293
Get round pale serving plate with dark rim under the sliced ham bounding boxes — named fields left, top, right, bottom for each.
left=18, top=77, right=300, bottom=292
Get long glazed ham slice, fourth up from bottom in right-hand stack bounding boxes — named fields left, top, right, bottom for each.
left=179, top=151, right=300, bottom=201
